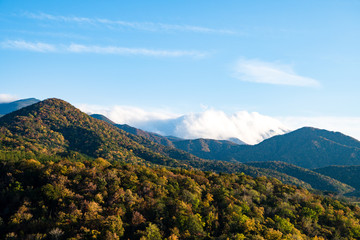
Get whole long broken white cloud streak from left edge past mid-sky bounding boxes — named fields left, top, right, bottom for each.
left=0, top=40, right=207, bottom=58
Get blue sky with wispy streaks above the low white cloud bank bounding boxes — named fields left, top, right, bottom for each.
left=0, top=0, right=360, bottom=136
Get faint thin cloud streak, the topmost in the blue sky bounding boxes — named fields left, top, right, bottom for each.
left=25, top=13, right=236, bottom=34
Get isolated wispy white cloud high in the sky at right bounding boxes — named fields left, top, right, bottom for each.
left=234, top=59, right=320, bottom=87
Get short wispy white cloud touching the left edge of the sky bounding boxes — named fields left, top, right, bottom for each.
left=0, top=40, right=57, bottom=53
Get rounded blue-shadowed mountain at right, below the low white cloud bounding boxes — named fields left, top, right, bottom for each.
left=232, top=127, right=360, bottom=168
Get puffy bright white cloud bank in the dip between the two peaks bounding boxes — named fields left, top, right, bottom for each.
left=79, top=105, right=289, bottom=144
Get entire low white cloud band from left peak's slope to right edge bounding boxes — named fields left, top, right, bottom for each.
left=78, top=102, right=360, bottom=144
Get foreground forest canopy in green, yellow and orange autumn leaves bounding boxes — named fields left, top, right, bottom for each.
left=0, top=158, right=360, bottom=239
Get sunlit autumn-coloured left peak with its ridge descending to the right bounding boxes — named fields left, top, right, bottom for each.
left=0, top=99, right=350, bottom=193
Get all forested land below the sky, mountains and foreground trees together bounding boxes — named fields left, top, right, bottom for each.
left=0, top=98, right=360, bottom=239
